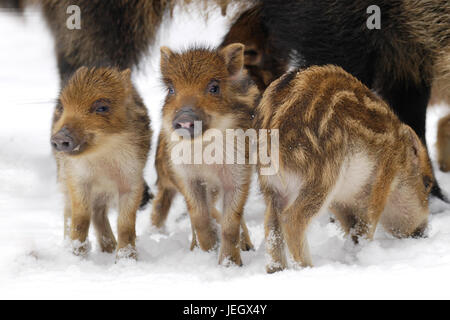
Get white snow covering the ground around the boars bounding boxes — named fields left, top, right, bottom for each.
left=0, top=5, right=450, bottom=299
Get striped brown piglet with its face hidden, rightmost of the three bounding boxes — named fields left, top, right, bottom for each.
left=256, top=66, right=434, bottom=272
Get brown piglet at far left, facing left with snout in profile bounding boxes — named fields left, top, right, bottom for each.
left=51, top=68, right=152, bottom=258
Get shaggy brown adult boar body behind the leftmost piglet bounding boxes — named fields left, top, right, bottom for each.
left=36, top=0, right=253, bottom=81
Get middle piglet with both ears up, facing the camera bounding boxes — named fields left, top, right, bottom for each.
left=152, top=44, right=260, bottom=265
